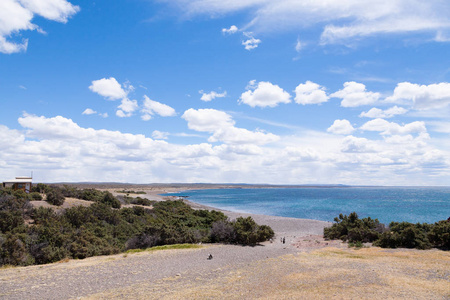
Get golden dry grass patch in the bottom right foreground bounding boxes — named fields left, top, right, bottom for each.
left=85, top=247, right=450, bottom=299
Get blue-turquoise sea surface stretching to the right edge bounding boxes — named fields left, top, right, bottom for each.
left=168, top=187, right=450, bottom=224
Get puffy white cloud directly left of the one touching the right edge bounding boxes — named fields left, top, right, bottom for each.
left=330, top=81, right=380, bottom=107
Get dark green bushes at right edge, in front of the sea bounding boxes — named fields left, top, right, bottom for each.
left=324, top=213, right=450, bottom=250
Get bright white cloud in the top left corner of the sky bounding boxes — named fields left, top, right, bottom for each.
left=0, top=0, right=80, bottom=54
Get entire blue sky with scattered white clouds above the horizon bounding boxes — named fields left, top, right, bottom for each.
left=0, top=0, right=450, bottom=186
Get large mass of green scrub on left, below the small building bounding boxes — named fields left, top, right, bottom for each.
left=0, top=185, right=274, bottom=266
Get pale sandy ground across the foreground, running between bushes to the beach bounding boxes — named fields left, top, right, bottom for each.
left=4, top=186, right=450, bottom=299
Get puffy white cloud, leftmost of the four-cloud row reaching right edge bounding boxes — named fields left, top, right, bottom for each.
left=240, top=80, right=291, bottom=107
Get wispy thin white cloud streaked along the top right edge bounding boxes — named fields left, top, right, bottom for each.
left=160, top=0, right=450, bottom=44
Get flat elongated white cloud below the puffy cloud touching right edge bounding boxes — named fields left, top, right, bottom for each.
left=360, top=119, right=427, bottom=135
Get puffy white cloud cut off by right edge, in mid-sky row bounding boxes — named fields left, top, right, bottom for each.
left=386, top=82, right=450, bottom=110
